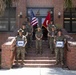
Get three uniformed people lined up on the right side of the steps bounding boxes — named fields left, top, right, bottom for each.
left=47, top=21, right=66, bottom=65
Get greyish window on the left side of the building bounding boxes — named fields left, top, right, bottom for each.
left=0, top=7, right=16, bottom=32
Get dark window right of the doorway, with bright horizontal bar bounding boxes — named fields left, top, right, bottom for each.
left=64, top=8, right=76, bottom=33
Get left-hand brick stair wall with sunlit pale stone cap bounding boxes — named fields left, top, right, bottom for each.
left=1, top=37, right=15, bottom=69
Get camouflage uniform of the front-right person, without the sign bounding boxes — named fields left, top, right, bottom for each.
left=55, top=36, right=65, bottom=64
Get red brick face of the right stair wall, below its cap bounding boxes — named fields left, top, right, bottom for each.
left=67, top=45, right=76, bottom=70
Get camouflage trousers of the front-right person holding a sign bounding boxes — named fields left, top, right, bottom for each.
left=55, top=48, right=64, bottom=62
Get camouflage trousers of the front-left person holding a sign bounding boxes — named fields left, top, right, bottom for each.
left=16, top=47, right=25, bottom=63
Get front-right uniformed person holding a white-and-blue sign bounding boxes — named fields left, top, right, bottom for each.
left=54, top=30, right=66, bottom=65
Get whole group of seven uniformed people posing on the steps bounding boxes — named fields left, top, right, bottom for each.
left=16, top=17, right=66, bottom=65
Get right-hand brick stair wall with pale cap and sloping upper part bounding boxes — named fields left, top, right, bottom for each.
left=62, top=29, right=76, bottom=70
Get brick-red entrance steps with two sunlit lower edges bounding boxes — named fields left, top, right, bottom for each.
left=15, top=41, right=59, bottom=67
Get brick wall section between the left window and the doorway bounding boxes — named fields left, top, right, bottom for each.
left=16, top=0, right=26, bottom=26
